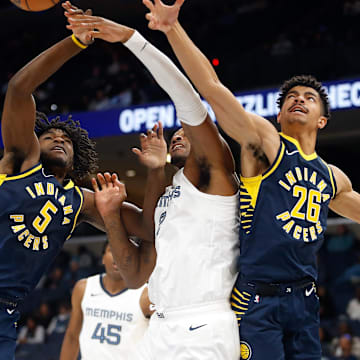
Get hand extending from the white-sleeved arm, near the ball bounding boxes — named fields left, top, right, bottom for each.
left=63, top=1, right=134, bottom=42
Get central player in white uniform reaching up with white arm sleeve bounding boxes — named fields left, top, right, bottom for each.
left=67, top=5, right=240, bottom=360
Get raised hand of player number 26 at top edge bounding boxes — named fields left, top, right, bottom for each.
left=143, top=0, right=185, bottom=34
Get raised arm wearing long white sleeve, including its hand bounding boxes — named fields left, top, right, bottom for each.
left=66, top=11, right=234, bottom=183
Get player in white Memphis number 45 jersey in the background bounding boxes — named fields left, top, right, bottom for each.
left=60, top=242, right=152, bottom=360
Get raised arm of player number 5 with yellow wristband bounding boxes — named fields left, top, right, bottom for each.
left=0, top=6, right=93, bottom=172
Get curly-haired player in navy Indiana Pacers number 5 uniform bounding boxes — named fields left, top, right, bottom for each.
left=0, top=11, right=156, bottom=360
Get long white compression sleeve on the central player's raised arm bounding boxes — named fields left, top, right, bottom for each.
left=124, top=31, right=207, bottom=126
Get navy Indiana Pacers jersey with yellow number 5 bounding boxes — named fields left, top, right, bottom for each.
left=0, top=164, right=83, bottom=302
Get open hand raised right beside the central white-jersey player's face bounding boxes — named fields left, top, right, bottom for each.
left=132, top=122, right=167, bottom=169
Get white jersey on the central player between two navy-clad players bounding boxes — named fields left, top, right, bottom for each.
left=149, top=169, right=239, bottom=311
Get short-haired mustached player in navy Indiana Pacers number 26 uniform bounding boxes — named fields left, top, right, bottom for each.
left=144, top=0, right=360, bottom=360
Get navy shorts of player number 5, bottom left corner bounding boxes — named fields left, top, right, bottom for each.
left=0, top=304, right=20, bottom=360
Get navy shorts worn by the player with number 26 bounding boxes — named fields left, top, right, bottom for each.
left=231, top=278, right=321, bottom=360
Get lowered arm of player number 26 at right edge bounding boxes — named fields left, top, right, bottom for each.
left=330, top=165, right=360, bottom=224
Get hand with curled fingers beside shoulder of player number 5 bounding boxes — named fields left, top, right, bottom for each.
left=91, top=172, right=126, bottom=218
